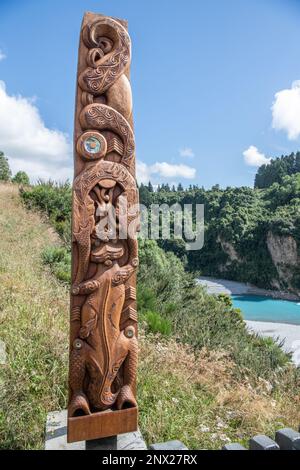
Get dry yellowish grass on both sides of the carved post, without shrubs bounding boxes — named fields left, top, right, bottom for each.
left=0, top=185, right=300, bottom=449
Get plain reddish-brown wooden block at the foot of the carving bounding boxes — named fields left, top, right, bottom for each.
left=68, top=407, right=138, bottom=442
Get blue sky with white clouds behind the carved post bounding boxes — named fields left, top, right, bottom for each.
left=0, top=0, right=300, bottom=187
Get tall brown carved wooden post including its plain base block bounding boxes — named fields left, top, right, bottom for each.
left=68, top=13, right=138, bottom=442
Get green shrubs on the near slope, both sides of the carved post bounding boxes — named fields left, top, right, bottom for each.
left=21, top=182, right=286, bottom=378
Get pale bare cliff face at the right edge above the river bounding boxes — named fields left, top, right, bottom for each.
left=267, top=231, right=300, bottom=287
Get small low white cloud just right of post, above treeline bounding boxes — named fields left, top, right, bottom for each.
left=137, top=161, right=196, bottom=183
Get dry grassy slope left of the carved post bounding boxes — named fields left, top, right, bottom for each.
left=0, top=184, right=68, bottom=449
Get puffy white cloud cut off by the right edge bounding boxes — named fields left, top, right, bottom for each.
left=272, top=80, right=300, bottom=140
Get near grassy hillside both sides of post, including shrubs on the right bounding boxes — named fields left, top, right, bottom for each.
left=0, top=185, right=300, bottom=449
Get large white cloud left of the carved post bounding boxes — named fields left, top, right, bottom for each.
left=0, top=81, right=72, bottom=180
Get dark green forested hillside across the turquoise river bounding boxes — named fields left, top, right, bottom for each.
left=140, top=153, right=300, bottom=297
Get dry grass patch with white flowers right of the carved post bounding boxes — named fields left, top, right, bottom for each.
left=139, top=332, right=300, bottom=449
